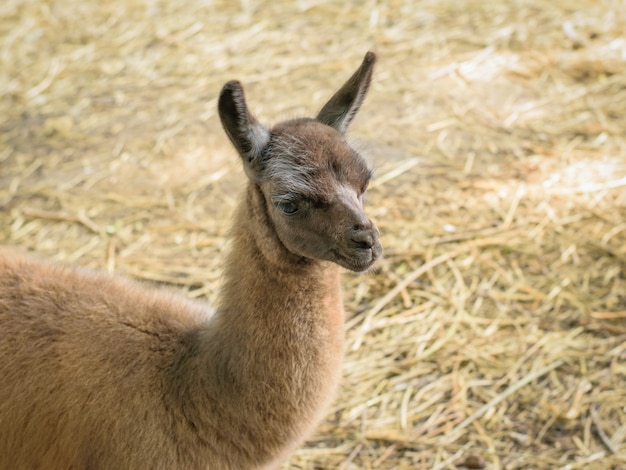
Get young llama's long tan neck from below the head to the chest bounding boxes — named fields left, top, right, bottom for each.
left=173, top=185, right=344, bottom=461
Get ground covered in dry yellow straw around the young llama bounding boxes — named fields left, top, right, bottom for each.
left=0, top=0, right=626, bottom=469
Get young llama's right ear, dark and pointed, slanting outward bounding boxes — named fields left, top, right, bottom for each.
left=317, top=52, right=376, bottom=134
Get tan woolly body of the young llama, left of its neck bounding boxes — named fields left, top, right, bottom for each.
left=0, top=250, right=208, bottom=469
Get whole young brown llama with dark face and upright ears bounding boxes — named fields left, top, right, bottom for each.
left=0, top=52, right=382, bottom=470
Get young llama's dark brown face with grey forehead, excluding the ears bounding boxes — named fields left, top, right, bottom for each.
left=258, top=119, right=382, bottom=271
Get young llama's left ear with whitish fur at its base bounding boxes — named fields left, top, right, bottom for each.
left=217, top=80, right=270, bottom=178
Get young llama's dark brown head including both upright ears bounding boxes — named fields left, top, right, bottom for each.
left=218, top=52, right=382, bottom=271
